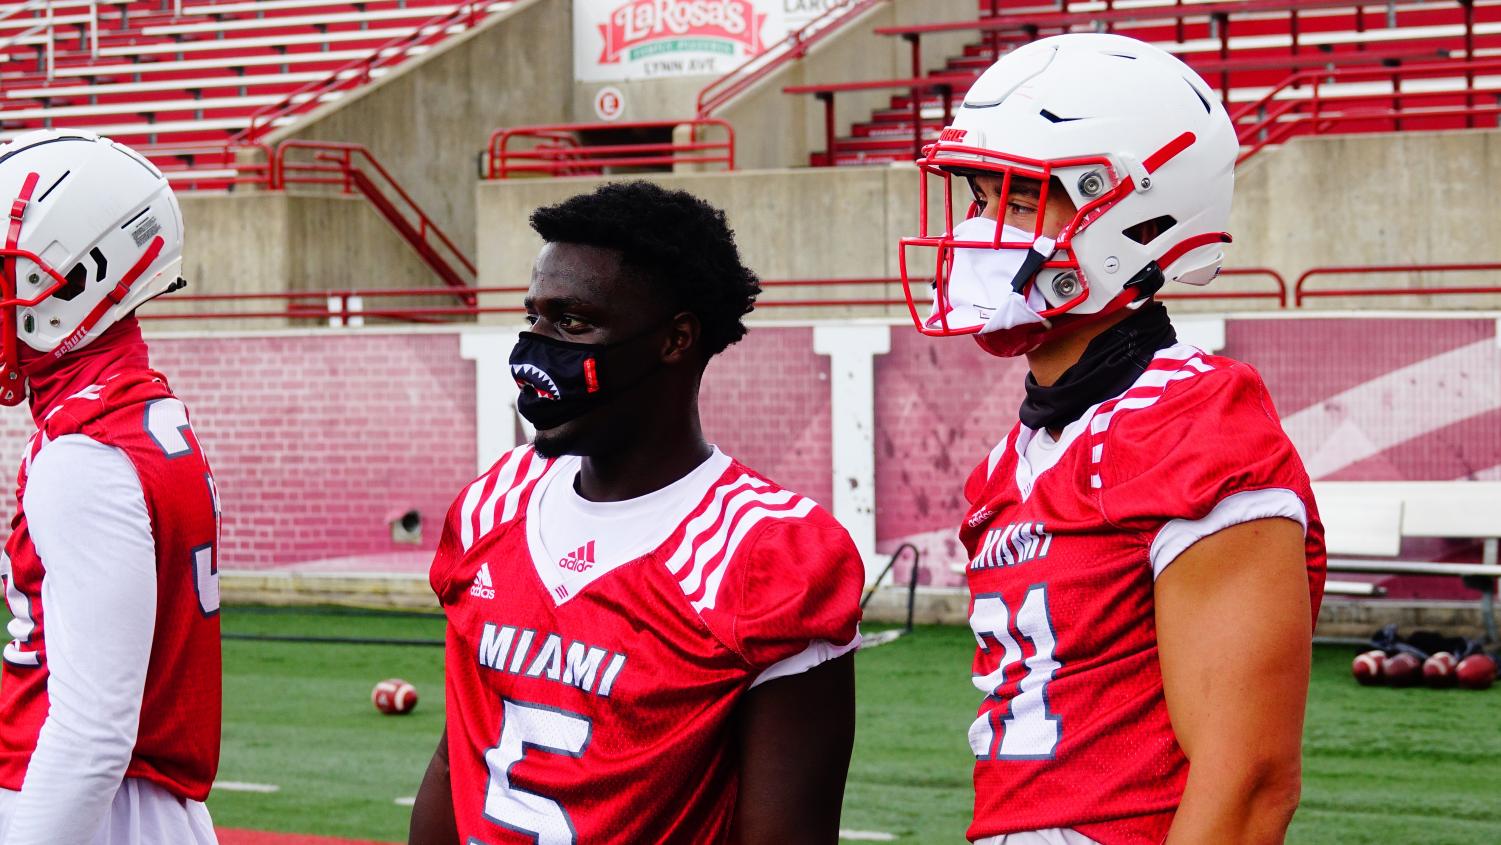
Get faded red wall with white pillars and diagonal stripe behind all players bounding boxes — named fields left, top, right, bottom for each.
left=0, top=315, right=1501, bottom=587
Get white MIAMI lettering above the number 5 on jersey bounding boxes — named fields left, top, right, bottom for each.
left=479, top=621, right=626, bottom=698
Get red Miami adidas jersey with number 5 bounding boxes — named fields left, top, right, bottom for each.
left=431, top=446, right=865, bottom=845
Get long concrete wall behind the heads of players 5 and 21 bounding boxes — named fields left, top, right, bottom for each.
left=476, top=131, right=1501, bottom=318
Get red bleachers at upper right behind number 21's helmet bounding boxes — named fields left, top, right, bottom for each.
left=790, top=0, right=1501, bottom=167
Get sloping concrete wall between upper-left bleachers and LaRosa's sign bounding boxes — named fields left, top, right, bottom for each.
left=269, top=0, right=573, bottom=255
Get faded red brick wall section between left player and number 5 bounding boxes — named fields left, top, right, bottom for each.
left=0, top=333, right=474, bottom=569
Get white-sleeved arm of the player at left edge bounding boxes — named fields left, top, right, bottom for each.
left=6, top=435, right=158, bottom=845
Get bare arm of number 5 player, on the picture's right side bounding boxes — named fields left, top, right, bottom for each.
left=735, top=653, right=854, bottom=845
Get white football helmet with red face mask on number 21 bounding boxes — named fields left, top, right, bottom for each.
left=901, top=33, right=1240, bottom=356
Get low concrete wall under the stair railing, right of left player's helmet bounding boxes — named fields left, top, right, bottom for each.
left=167, top=192, right=453, bottom=330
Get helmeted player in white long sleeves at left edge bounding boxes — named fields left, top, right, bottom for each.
left=0, top=131, right=221, bottom=845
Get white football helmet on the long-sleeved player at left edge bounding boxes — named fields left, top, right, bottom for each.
left=0, top=129, right=186, bottom=405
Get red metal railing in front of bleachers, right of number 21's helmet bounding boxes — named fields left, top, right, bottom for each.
left=1231, top=59, right=1501, bottom=164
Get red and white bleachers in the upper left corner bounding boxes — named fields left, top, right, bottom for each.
left=0, top=0, right=510, bottom=144
